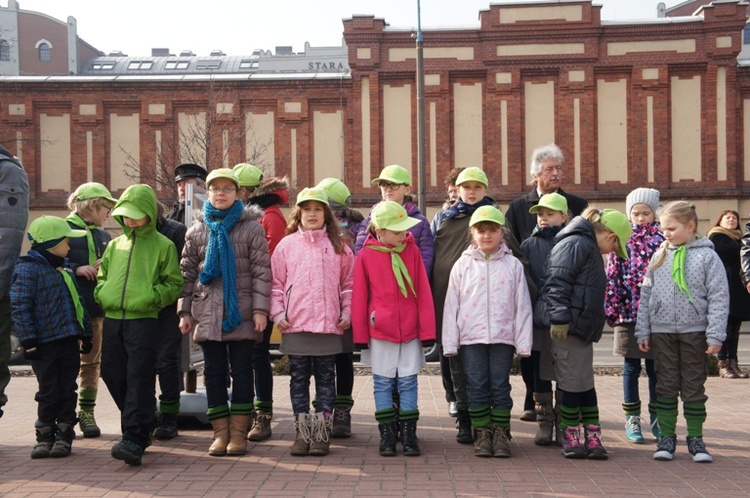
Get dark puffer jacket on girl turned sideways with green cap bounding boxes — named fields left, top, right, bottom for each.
left=534, top=216, right=607, bottom=342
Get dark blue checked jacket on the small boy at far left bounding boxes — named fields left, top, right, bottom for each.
left=10, top=251, right=92, bottom=344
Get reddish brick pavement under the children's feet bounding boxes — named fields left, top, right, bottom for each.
left=0, top=375, right=750, bottom=498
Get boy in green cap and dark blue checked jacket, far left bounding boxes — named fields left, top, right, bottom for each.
left=10, top=216, right=92, bottom=458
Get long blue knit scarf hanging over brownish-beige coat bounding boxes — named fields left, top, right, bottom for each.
left=199, top=200, right=244, bottom=332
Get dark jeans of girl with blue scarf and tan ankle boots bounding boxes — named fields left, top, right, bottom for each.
left=201, top=341, right=255, bottom=408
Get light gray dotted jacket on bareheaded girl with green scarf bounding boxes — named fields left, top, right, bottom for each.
left=635, top=237, right=729, bottom=346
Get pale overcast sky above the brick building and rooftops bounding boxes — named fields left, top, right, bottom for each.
left=11, top=0, right=682, bottom=55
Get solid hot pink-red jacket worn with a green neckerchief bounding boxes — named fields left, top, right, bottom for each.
left=352, top=233, right=435, bottom=344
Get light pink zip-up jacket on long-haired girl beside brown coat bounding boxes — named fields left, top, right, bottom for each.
left=271, top=227, right=354, bottom=335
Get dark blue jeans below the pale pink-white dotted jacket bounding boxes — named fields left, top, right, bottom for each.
left=458, top=344, right=516, bottom=410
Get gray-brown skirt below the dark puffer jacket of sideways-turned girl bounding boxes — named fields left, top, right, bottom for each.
left=551, top=334, right=594, bottom=393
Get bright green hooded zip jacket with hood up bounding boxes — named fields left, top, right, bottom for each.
left=94, top=185, right=183, bottom=320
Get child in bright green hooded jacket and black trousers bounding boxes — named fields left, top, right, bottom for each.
left=94, top=185, right=183, bottom=465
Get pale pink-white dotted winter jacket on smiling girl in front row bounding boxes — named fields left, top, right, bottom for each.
left=442, top=244, right=533, bottom=356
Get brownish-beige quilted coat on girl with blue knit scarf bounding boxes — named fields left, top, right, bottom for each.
left=177, top=206, right=271, bottom=343
